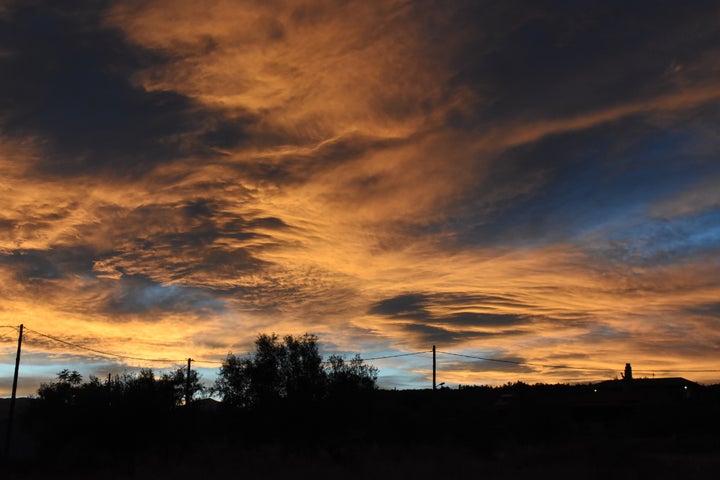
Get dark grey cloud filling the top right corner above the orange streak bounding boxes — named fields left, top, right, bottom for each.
left=436, top=0, right=720, bottom=125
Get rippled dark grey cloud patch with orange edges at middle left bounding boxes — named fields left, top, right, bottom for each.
left=0, top=198, right=282, bottom=300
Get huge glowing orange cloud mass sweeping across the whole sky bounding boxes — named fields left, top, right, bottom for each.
left=0, top=0, right=720, bottom=394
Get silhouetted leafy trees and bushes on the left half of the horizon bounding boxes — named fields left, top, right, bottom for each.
left=38, top=333, right=378, bottom=410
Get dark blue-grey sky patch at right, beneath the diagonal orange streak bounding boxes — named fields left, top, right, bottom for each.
left=414, top=118, right=718, bottom=256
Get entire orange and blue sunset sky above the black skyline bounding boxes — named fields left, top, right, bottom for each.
left=0, top=0, right=720, bottom=395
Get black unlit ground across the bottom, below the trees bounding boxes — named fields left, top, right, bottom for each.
left=2, top=387, right=720, bottom=480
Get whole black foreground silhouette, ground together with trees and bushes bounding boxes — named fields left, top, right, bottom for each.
left=2, top=336, right=720, bottom=479
